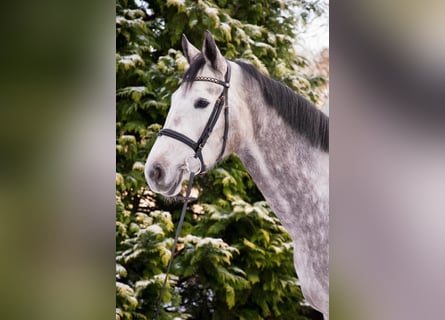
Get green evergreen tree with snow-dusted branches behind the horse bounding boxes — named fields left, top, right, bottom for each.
left=116, top=0, right=324, bottom=320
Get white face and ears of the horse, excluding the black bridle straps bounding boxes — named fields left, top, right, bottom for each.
left=145, top=33, right=227, bottom=196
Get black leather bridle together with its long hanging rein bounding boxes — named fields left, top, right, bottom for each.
left=153, top=62, right=230, bottom=320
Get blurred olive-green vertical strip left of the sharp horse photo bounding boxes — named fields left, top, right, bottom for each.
left=0, top=0, right=115, bottom=319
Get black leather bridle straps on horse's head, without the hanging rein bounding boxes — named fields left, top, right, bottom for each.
left=158, top=62, right=230, bottom=174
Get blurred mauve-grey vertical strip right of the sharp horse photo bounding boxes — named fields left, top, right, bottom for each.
left=330, top=1, right=445, bottom=319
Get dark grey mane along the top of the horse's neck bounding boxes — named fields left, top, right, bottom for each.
left=235, top=60, right=329, bottom=152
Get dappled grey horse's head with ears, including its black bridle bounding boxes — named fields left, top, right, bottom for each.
left=145, top=32, right=236, bottom=196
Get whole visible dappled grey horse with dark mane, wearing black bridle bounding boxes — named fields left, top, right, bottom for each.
left=145, top=31, right=329, bottom=320
